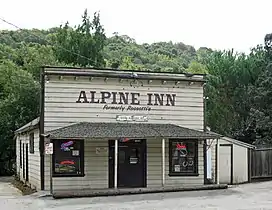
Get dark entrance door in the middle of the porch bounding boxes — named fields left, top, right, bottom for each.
left=109, top=139, right=146, bottom=188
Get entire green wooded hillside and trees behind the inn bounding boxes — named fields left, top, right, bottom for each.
left=0, top=11, right=272, bottom=175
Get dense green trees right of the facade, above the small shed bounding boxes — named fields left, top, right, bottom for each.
left=204, top=46, right=270, bottom=146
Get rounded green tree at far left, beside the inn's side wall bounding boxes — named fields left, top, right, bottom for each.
left=0, top=60, right=39, bottom=175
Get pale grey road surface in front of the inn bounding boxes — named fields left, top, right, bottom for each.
left=0, top=178, right=272, bottom=210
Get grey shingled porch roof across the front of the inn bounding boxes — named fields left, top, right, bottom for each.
left=45, top=122, right=220, bottom=139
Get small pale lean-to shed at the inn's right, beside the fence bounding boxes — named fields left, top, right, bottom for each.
left=218, top=136, right=255, bottom=184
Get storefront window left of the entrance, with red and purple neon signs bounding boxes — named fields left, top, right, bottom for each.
left=53, top=140, right=84, bottom=176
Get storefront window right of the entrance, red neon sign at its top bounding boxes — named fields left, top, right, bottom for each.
left=169, top=139, right=198, bottom=176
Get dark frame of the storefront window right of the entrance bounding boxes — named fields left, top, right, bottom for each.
left=168, top=138, right=199, bottom=176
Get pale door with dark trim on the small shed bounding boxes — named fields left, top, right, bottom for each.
left=219, top=145, right=232, bottom=184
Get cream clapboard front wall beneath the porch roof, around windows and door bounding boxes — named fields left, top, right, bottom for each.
left=50, top=139, right=204, bottom=190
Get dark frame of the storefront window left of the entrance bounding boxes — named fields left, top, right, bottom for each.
left=51, top=139, right=85, bottom=177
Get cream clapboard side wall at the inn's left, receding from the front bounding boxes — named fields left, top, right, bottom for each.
left=16, top=129, right=40, bottom=190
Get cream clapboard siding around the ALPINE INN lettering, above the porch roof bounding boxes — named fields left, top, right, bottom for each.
left=44, top=76, right=203, bottom=131
